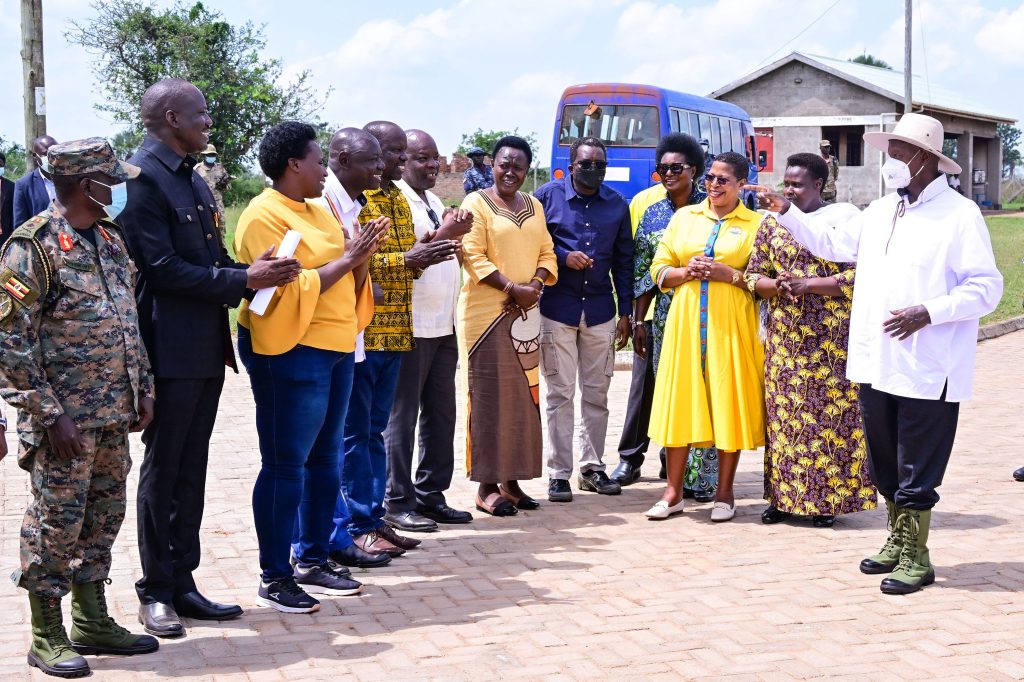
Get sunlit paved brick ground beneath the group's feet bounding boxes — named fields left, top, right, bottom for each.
left=0, top=333, right=1024, bottom=680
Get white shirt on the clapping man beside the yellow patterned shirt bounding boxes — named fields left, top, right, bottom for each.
left=395, top=180, right=461, bottom=339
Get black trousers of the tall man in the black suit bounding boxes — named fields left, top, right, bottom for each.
left=135, top=375, right=224, bottom=603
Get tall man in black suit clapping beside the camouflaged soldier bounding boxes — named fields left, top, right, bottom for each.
left=119, top=79, right=299, bottom=637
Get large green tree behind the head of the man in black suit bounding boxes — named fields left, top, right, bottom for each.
left=66, top=0, right=324, bottom=173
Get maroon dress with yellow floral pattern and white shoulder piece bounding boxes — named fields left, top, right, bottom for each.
left=746, top=204, right=876, bottom=516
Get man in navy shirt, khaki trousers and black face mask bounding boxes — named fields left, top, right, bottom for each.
left=536, top=137, right=633, bottom=502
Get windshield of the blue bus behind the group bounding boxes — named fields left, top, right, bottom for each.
left=558, top=102, right=662, bottom=146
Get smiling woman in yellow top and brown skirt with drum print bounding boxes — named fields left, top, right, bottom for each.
left=459, top=135, right=558, bottom=516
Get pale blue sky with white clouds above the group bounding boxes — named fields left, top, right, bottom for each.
left=0, top=0, right=1024, bottom=165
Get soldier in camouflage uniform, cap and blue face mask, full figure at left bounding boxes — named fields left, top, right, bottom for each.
left=0, top=137, right=158, bottom=677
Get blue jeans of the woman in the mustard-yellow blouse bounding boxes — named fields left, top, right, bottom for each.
left=239, top=326, right=354, bottom=582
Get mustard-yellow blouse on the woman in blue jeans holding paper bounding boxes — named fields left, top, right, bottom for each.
left=234, top=187, right=374, bottom=355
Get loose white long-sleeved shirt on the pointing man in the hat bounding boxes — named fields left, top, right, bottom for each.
left=777, top=175, right=1002, bottom=402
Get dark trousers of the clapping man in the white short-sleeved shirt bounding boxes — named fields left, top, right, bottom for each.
left=384, top=334, right=459, bottom=514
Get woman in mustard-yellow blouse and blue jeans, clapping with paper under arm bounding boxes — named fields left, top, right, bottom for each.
left=234, top=122, right=389, bottom=613
